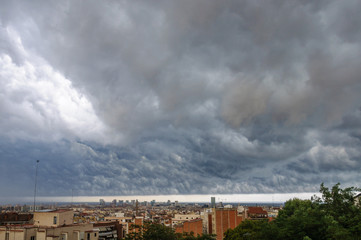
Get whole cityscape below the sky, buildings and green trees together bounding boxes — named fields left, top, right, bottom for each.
left=0, top=187, right=361, bottom=240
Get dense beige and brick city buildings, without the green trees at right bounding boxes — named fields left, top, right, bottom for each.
left=0, top=197, right=283, bottom=240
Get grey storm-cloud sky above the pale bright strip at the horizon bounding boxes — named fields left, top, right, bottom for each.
left=0, top=0, right=361, bottom=197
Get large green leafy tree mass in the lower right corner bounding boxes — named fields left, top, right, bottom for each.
left=224, top=183, right=361, bottom=240
